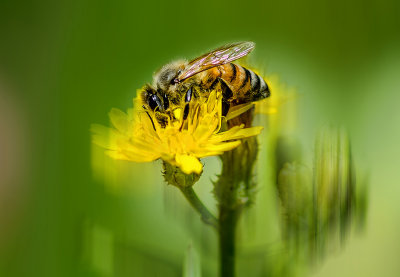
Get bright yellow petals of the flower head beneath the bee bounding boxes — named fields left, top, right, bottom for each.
left=92, top=89, right=263, bottom=174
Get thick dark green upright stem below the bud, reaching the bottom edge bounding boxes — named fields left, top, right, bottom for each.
left=219, top=207, right=238, bottom=277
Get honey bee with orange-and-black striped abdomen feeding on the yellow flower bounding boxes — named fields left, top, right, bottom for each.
left=141, top=42, right=270, bottom=126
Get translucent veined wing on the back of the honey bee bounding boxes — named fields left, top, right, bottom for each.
left=177, top=41, right=255, bottom=82
